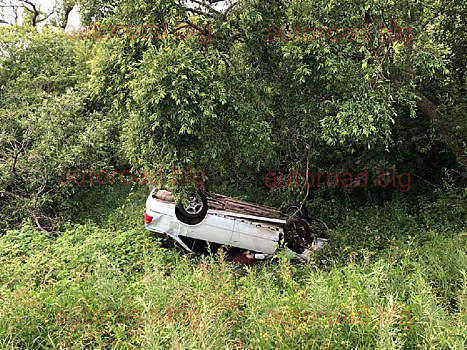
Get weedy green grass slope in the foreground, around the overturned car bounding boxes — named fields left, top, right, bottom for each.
left=0, top=188, right=467, bottom=349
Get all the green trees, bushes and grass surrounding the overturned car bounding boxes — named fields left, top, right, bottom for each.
left=0, top=0, right=467, bottom=349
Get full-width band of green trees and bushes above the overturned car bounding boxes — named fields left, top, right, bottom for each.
left=0, top=0, right=467, bottom=231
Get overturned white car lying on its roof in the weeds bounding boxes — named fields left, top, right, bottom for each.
left=145, top=189, right=329, bottom=259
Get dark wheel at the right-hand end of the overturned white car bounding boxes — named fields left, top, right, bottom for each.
left=284, top=218, right=316, bottom=254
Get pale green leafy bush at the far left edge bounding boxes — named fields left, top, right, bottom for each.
left=0, top=27, right=119, bottom=230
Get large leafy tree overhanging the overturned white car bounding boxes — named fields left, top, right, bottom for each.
left=87, top=1, right=463, bottom=200
